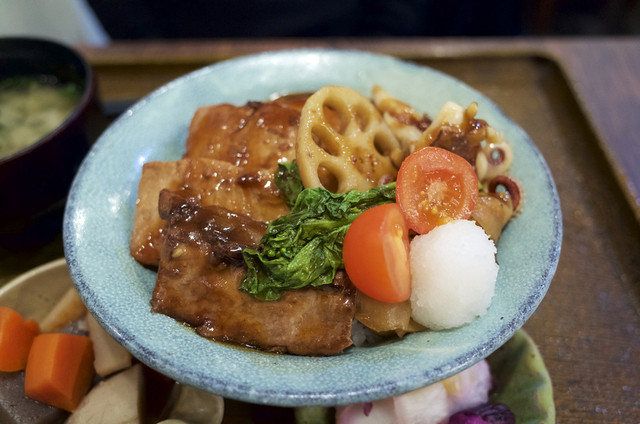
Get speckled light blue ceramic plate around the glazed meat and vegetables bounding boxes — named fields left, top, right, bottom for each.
left=64, top=50, right=562, bottom=406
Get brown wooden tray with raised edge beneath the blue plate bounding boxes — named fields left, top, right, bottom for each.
left=0, top=50, right=640, bottom=423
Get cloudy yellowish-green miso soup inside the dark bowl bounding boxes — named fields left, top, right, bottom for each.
left=0, top=77, right=82, bottom=158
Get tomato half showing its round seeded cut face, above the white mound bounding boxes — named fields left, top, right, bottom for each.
left=396, top=147, right=478, bottom=234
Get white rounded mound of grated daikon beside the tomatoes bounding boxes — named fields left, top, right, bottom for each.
left=410, top=220, right=498, bottom=330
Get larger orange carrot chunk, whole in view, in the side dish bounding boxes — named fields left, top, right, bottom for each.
left=24, top=333, right=94, bottom=412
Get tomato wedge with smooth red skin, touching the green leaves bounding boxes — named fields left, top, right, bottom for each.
left=342, top=203, right=411, bottom=303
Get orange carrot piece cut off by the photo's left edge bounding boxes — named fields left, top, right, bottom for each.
left=0, top=306, right=40, bottom=372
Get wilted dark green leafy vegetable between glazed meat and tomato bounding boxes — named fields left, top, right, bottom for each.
left=240, top=165, right=395, bottom=300
